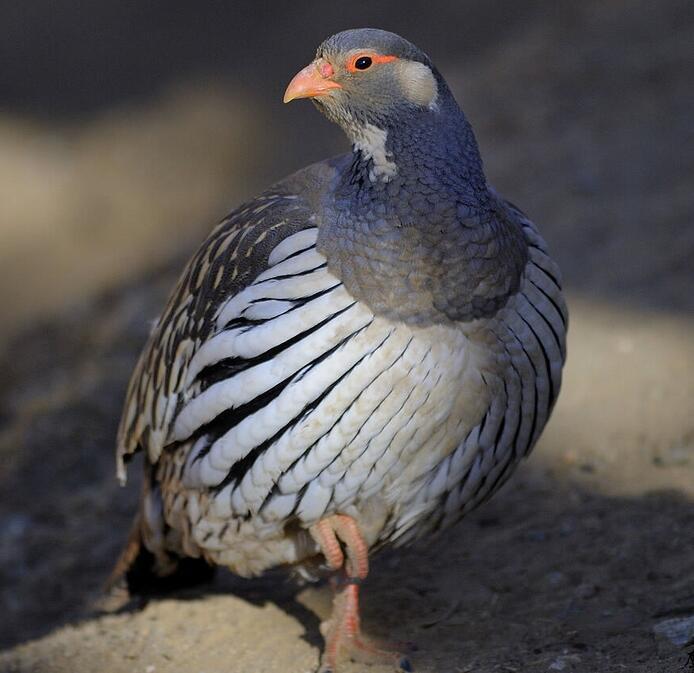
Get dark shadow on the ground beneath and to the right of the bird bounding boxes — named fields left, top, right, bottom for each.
left=85, top=470, right=694, bottom=671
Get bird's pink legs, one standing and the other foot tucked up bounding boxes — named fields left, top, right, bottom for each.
left=311, top=514, right=412, bottom=673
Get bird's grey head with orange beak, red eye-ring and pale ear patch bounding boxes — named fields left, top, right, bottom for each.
left=284, top=28, right=445, bottom=138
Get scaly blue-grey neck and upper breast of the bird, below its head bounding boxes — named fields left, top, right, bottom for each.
left=318, top=96, right=527, bottom=326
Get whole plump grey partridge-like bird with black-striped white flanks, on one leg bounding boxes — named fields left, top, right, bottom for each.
left=114, top=28, right=568, bottom=673
